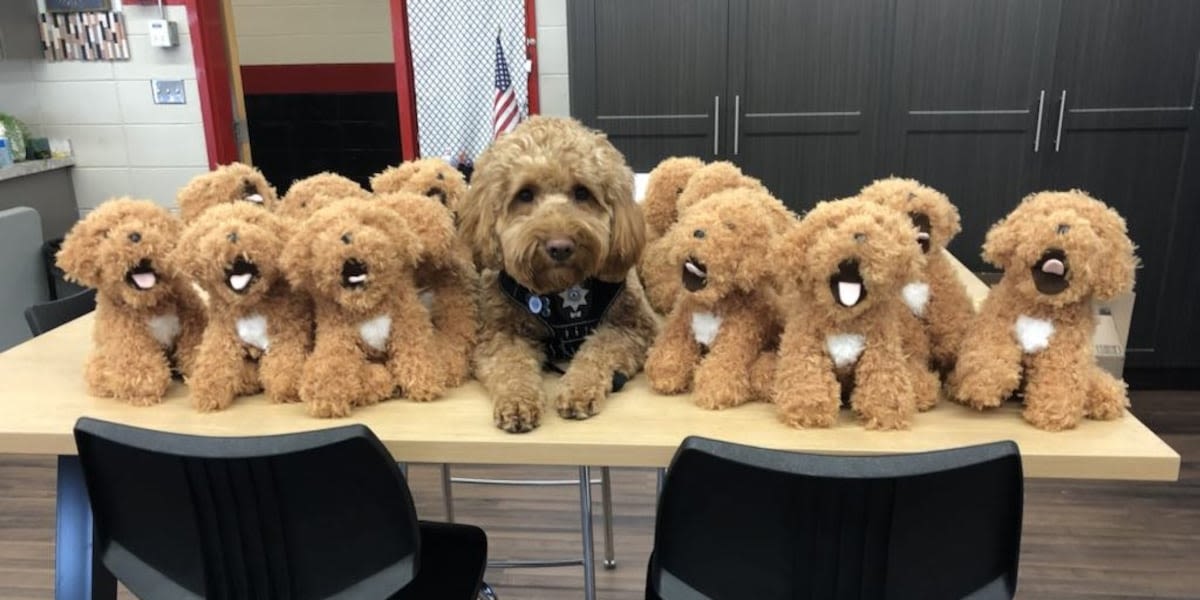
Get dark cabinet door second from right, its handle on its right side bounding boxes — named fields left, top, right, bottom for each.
left=884, top=0, right=1058, bottom=269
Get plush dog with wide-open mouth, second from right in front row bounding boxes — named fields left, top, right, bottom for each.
left=773, top=198, right=936, bottom=430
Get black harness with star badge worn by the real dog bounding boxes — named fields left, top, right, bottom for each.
left=499, top=271, right=629, bottom=391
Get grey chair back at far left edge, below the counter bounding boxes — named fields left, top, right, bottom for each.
left=0, top=206, right=50, bottom=352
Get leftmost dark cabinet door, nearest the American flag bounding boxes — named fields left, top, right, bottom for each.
left=568, top=0, right=728, bottom=172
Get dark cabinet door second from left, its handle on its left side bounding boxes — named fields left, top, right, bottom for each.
left=726, top=0, right=890, bottom=210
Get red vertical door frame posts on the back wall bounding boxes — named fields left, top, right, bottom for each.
left=186, top=0, right=541, bottom=169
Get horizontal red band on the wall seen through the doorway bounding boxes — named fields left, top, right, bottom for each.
left=241, top=62, right=396, bottom=94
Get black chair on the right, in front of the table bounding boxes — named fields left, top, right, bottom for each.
left=646, top=433, right=1024, bottom=600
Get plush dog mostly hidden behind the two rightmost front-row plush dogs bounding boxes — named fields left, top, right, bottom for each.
left=859, top=178, right=974, bottom=373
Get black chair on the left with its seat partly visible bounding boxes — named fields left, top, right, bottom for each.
left=74, top=418, right=487, bottom=600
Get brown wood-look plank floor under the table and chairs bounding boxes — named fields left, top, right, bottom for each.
left=0, top=391, right=1200, bottom=600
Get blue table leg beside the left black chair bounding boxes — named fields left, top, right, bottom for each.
left=54, top=456, right=116, bottom=600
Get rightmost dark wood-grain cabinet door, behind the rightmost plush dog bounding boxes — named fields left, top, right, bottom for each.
left=1043, top=0, right=1200, bottom=366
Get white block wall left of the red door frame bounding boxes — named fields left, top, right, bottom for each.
left=0, top=2, right=208, bottom=212
